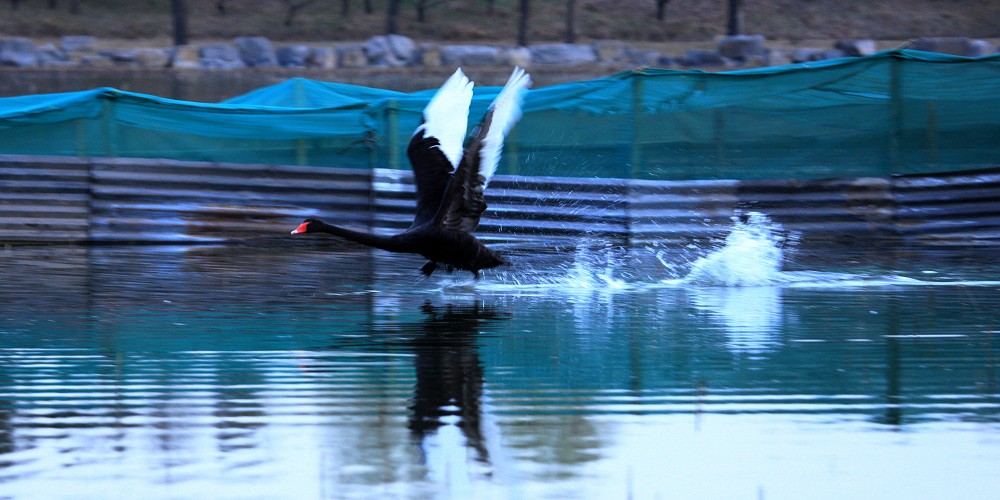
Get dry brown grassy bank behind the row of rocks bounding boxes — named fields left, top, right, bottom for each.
left=0, top=0, right=1000, bottom=43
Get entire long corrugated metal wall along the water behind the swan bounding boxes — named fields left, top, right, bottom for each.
left=0, top=155, right=1000, bottom=244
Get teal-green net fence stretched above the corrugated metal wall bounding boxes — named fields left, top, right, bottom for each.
left=0, top=50, right=1000, bottom=179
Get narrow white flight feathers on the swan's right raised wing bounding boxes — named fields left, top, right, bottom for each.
left=478, top=67, right=531, bottom=189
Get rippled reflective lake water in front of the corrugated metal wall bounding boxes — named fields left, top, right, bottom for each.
left=0, top=216, right=1000, bottom=499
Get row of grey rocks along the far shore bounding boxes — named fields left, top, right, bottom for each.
left=0, top=35, right=997, bottom=70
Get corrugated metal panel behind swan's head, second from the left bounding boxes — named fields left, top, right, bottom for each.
left=92, top=159, right=370, bottom=242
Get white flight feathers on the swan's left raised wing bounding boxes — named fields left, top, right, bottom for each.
left=414, top=68, right=472, bottom=168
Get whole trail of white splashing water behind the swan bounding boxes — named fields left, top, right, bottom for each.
left=434, top=212, right=998, bottom=294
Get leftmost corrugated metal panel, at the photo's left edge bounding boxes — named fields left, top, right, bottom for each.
left=0, top=156, right=90, bottom=243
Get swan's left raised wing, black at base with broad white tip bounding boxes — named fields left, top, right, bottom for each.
left=406, top=68, right=472, bottom=227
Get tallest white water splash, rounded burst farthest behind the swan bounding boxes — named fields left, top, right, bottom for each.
left=680, top=212, right=789, bottom=287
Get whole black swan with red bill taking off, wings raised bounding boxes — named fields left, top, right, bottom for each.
left=292, top=67, right=531, bottom=279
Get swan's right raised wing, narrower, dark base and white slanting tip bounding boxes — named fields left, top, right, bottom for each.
left=437, top=68, right=531, bottom=232
